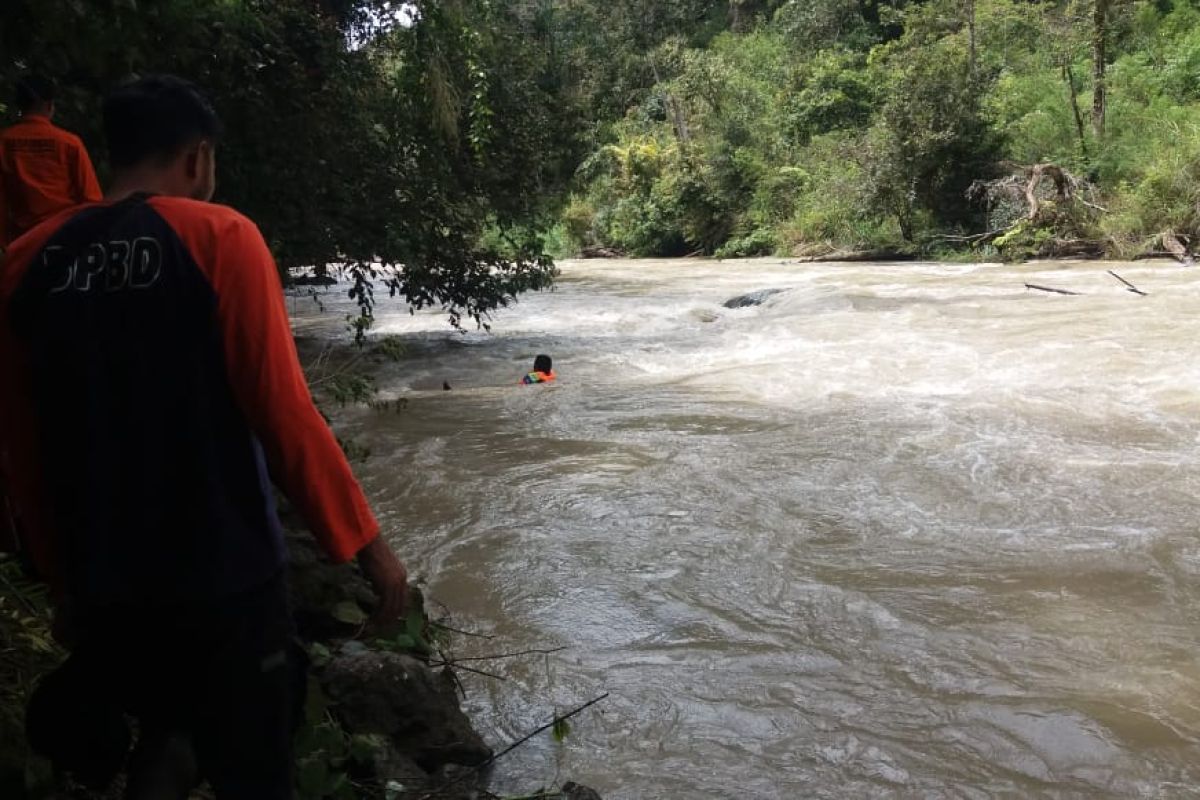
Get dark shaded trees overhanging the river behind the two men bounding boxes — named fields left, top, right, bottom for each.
left=0, top=0, right=582, bottom=325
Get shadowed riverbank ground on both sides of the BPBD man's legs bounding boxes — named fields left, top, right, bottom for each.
left=0, top=510, right=600, bottom=800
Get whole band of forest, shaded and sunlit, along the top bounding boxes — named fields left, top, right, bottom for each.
left=0, top=0, right=1200, bottom=323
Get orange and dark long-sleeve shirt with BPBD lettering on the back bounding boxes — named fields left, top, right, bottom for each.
left=0, top=196, right=379, bottom=604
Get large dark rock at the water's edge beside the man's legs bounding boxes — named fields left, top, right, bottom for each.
left=320, top=651, right=492, bottom=772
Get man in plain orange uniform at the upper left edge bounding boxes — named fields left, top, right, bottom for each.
left=0, top=76, right=101, bottom=248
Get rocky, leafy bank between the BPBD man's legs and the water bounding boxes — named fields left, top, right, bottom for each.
left=266, top=513, right=600, bottom=800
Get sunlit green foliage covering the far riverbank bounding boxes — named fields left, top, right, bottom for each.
left=554, top=0, right=1200, bottom=255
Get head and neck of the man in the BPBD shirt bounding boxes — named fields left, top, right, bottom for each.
left=104, top=76, right=221, bottom=200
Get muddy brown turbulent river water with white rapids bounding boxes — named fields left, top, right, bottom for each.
left=293, top=260, right=1200, bottom=799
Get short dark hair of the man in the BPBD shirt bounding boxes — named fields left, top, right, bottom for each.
left=104, top=76, right=221, bottom=169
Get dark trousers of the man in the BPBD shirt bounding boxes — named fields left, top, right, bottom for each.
left=26, top=576, right=305, bottom=800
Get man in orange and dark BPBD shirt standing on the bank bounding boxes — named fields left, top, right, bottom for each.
left=0, top=77, right=408, bottom=800
